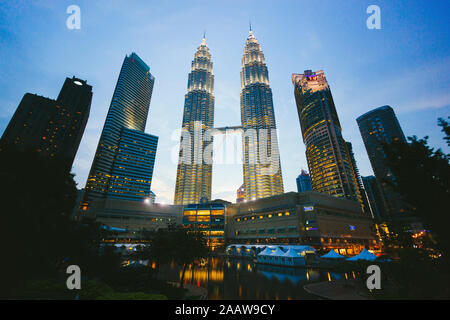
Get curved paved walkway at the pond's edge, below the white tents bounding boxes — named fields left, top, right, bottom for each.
left=303, top=280, right=369, bottom=300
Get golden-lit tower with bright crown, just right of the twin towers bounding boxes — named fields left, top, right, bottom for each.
left=292, top=70, right=362, bottom=203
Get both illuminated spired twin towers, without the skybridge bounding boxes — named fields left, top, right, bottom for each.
left=174, top=30, right=283, bottom=204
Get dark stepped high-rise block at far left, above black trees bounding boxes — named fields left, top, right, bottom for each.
left=2, top=77, right=92, bottom=170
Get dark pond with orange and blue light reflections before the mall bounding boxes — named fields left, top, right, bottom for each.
left=158, top=258, right=352, bottom=300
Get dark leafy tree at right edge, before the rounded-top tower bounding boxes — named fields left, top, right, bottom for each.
left=384, top=125, right=450, bottom=256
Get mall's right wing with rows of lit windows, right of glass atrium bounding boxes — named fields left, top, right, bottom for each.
left=225, top=191, right=381, bottom=254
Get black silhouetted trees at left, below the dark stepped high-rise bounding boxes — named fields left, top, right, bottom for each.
left=0, top=144, right=119, bottom=297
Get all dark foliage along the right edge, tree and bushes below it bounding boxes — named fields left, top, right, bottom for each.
left=372, top=119, right=450, bottom=299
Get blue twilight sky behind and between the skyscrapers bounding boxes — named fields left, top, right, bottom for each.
left=0, top=0, right=450, bottom=203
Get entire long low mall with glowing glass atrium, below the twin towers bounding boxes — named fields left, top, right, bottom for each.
left=83, top=191, right=381, bottom=254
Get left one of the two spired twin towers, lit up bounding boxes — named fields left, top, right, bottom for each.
left=174, top=37, right=214, bottom=204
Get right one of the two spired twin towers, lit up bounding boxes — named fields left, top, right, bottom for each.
left=241, top=29, right=283, bottom=200
